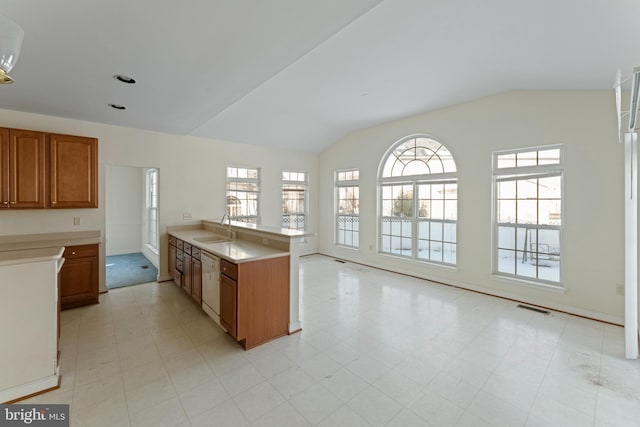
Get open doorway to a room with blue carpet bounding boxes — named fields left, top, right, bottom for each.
left=105, top=165, right=160, bottom=289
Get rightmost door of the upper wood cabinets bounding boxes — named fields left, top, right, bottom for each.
left=49, top=134, right=98, bottom=208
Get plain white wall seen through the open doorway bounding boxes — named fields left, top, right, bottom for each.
left=104, top=165, right=144, bottom=256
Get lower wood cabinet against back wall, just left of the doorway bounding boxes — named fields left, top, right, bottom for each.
left=60, top=244, right=98, bottom=310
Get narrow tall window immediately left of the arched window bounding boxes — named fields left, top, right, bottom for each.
left=335, top=169, right=360, bottom=248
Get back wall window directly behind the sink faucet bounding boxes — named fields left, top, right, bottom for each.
left=227, top=166, right=260, bottom=224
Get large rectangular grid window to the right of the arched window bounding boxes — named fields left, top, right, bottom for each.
left=493, top=146, right=562, bottom=286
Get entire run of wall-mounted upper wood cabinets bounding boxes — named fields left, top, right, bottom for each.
left=0, top=128, right=98, bottom=209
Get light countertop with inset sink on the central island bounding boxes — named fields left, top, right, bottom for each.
left=169, top=229, right=289, bottom=264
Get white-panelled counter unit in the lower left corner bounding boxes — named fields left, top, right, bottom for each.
left=0, top=247, right=64, bottom=403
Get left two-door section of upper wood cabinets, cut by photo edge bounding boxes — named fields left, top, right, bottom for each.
left=0, top=128, right=47, bottom=208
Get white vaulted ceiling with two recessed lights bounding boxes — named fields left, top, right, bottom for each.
left=0, top=0, right=640, bottom=152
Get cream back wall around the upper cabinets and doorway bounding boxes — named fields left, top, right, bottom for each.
left=0, top=110, right=318, bottom=290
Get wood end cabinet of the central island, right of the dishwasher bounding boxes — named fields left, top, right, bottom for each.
left=220, top=256, right=289, bottom=349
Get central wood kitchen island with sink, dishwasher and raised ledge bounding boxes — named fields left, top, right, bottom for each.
left=167, top=220, right=307, bottom=349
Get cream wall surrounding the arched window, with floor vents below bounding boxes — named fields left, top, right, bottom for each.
left=318, top=91, right=624, bottom=323
